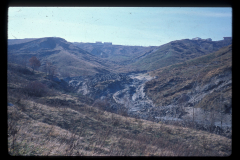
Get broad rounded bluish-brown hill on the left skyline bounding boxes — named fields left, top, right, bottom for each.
left=8, top=37, right=124, bottom=76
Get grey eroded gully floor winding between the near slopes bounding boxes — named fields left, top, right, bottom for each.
left=64, top=72, right=231, bottom=137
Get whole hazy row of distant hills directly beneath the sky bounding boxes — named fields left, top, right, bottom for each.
left=8, top=37, right=232, bottom=76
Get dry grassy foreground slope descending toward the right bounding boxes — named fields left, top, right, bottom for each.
left=8, top=64, right=231, bottom=156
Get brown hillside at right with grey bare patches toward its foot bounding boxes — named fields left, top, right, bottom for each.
left=145, top=45, right=232, bottom=135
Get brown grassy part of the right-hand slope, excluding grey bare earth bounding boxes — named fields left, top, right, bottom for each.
left=146, top=45, right=232, bottom=110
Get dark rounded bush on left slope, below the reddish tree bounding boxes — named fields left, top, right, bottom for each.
left=23, top=81, right=48, bottom=97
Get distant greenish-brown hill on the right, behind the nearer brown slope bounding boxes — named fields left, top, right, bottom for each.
left=128, top=39, right=232, bottom=70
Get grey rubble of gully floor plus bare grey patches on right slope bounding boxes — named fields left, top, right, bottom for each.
left=66, top=72, right=232, bottom=136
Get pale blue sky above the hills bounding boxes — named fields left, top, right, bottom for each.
left=8, top=7, right=232, bottom=46
